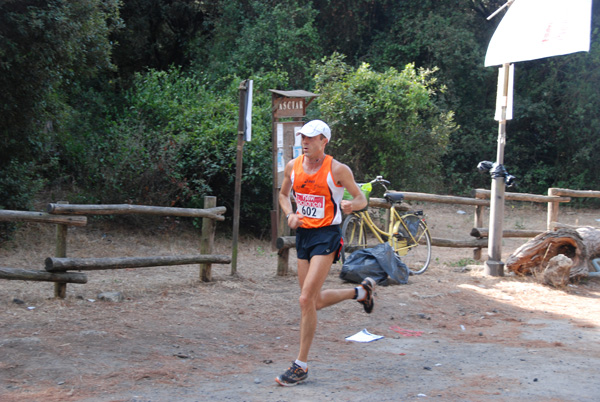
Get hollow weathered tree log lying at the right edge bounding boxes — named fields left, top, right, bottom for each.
left=505, top=225, right=600, bottom=278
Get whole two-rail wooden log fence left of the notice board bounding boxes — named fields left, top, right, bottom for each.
left=0, top=197, right=231, bottom=299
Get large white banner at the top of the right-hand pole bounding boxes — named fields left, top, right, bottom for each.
left=485, top=0, right=592, bottom=67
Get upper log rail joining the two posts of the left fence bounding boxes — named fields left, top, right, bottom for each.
left=46, top=204, right=227, bottom=221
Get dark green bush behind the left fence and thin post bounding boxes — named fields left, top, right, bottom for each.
left=61, top=68, right=281, bottom=230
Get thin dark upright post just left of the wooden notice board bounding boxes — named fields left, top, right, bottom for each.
left=231, top=80, right=247, bottom=275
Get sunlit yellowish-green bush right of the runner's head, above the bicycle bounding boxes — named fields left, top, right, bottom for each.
left=315, top=54, right=456, bottom=191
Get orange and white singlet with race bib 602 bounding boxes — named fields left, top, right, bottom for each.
left=291, top=155, right=344, bottom=229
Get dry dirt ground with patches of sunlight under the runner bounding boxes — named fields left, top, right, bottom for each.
left=0, top=204, right=600, bottom=402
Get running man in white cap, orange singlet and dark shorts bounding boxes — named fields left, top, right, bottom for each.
left=275, top=120, right=375, bottom=386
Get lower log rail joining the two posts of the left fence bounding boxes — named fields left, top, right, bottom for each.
left=45, top=254, right=231, bottom=272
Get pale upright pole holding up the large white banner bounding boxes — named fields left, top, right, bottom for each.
left=484, top=64, right=509, bottom=276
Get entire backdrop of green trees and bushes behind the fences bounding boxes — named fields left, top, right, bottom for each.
left=0, top=0, right=600, bottom=237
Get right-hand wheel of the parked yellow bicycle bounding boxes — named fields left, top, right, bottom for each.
left=394, top=214, right=431, bottom=275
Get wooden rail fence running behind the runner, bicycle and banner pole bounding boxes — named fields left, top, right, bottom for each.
left=276, top=188, right=600, bottom=275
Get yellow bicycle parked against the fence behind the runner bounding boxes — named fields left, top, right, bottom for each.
left=341, top=176, right=431, bottom=275
